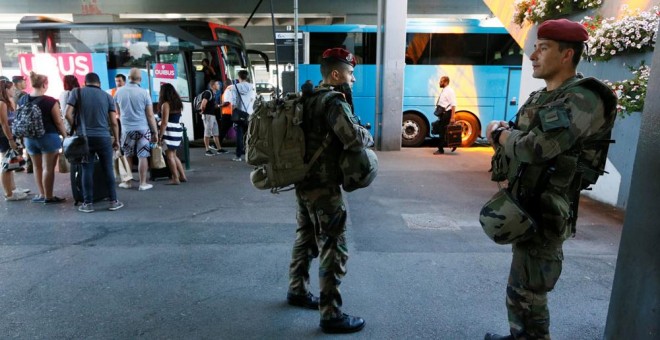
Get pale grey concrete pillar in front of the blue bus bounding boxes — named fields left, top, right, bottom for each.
left=373, top=0, right=408, bottom=151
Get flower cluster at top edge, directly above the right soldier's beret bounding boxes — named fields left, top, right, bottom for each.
left=513, top=0, right=603, bottom=26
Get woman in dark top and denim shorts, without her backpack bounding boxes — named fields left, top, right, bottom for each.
left=23, top=72, right=66, bottom=203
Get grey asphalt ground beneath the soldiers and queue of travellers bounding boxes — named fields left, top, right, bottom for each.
left=0, top=147, right=623, bottom=340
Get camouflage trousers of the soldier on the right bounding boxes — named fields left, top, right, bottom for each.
left=506, top=245, right=562, bottom=340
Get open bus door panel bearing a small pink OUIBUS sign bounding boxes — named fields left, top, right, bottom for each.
left=155, top=51, right=196, bottom=139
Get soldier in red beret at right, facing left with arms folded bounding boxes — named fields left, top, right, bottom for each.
left=482, top=19, right=616, bottom=340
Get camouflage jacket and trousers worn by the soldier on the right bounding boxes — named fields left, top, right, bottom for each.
left=501, top=76, right=613, bottom=339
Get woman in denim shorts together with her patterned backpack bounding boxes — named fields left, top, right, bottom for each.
left=17, top=71, right=67, bottom=204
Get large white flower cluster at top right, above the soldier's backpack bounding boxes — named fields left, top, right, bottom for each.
left=581, top=5, right=660, bottom=61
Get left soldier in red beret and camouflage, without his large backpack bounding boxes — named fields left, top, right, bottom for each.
left=287, top=48, right=373, bottom=333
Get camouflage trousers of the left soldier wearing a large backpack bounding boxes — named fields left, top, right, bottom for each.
left=289, top=186, right=348, bottom=319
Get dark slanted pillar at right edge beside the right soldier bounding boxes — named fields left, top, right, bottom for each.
left=605, top=25, right=660, bottom=340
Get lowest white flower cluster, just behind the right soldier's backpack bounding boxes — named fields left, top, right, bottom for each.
left=605, top=62, right=651, bottom=117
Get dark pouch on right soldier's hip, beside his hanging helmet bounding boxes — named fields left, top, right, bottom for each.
left=541, top=191, right=572, bottom=241
